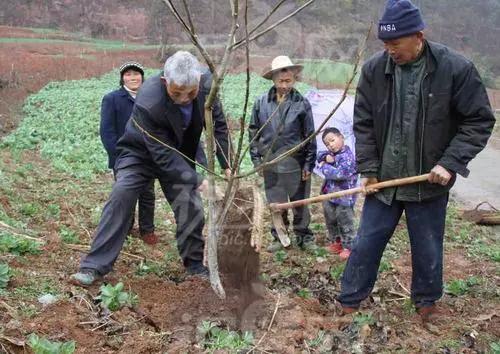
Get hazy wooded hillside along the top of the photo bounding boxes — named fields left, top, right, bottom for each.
left=0, top=0, right=500, bottom=87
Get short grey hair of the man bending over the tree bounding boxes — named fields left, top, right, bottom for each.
left=163, top=50, right=202, bottom=86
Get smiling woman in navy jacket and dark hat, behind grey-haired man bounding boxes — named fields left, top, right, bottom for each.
left=100, top=61, right=158, bottom=244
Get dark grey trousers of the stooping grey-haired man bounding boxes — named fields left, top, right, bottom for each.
left=80, top=165, right=205, bottom=275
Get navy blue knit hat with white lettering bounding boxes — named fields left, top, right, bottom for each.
left=378, top=0, right=425, bottom=41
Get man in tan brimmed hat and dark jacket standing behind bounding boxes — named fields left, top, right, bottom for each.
left=248, top=56, right=316, bottom=252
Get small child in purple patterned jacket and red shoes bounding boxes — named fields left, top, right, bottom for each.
left=317, top=128, right=358, bottom=260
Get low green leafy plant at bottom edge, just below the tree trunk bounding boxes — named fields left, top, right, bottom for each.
left=198, top=321, right=254, bottom=353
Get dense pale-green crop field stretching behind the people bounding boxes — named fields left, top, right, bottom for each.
left=0, top=70, right=310, bottom=180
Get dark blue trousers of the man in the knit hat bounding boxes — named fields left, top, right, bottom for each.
left=338, top=194, right=448, bottom=307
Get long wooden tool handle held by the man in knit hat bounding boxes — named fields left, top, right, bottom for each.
left=269, top=173, right=429, bottom=211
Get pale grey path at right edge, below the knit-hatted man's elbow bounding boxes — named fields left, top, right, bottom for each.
left=452, top=137, right=500, bottom=209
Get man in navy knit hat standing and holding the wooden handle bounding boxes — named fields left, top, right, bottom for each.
left=339, top=0, right=495, bottom=320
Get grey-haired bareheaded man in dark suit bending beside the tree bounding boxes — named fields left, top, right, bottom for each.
left=71, top=51, right=229, bottom=286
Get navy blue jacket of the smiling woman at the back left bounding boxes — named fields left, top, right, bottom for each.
left=99, top=87, right=134, bottom=168
